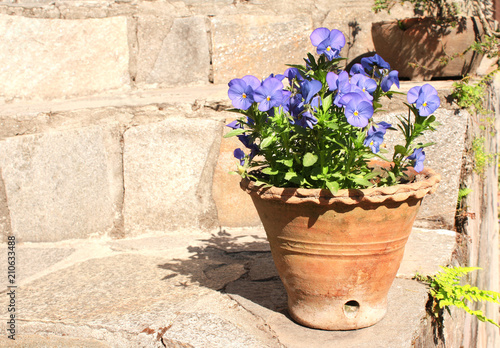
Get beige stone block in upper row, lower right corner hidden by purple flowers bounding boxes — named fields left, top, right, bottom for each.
left=212, top=14, right=314, bottom=83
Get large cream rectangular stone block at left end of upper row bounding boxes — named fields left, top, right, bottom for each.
left=0, top=15, right=130, bottom=100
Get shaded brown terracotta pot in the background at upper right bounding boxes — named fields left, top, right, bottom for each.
left=372, top=17, right=484, bottom=81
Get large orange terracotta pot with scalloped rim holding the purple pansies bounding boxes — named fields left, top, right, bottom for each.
left=241, top=168, right=440, bottom=330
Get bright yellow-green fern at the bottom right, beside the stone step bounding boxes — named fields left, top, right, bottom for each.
left=416, top=267, right=500, bottom=328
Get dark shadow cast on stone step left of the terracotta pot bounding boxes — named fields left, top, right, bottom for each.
left=158, top=230, right=287, bottom=312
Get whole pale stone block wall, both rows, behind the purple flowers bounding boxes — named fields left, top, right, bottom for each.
left=0, top=0, right=418, bottom=241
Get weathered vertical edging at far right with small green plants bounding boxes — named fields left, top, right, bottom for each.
left=457, top=75, right=500, bottom=348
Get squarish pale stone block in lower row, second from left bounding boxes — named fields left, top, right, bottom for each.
left=123, top=117, right=222, bottom=234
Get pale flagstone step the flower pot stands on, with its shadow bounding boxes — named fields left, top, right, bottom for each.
left=0, top=228, right=455, bottom=348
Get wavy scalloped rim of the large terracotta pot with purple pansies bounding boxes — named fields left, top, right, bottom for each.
left=240, top=168, right=441, bottom=205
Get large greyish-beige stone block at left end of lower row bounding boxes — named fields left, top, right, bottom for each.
left=0, top=126, right=114, bottom=242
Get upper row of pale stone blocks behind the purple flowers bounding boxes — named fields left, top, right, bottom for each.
left=0, top=0, right=410, bottom=103
